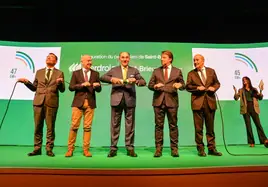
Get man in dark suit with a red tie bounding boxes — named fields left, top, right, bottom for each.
left=148, top=51, right=185, bottom=157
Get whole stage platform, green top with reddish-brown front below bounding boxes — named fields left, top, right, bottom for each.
left=0, top=145, right=268, bottom=187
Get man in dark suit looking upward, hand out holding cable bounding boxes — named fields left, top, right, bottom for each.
left=18, top=53, right=65, bottom=156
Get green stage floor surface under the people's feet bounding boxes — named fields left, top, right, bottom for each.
left=0, top=145, right=268, bottom=169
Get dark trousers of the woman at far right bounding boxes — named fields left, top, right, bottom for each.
left=243, top=101, right=267, bottom=144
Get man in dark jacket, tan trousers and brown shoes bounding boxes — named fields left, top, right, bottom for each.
left=65, top=55, right=101, bottom=157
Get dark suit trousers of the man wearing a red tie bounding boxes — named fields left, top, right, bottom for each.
left=154, top=102, right=179, bottom=151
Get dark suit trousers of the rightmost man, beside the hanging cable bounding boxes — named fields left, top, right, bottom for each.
left=193, top=97, right=216, bottom=151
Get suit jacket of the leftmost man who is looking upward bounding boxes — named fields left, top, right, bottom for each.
left=25, top=68, right=65, bottom=108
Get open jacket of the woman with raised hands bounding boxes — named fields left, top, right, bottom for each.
left=234, top=88, right=263, bottom=114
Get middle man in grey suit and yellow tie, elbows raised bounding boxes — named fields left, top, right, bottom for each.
left=100, top=52, right=146, bottom=157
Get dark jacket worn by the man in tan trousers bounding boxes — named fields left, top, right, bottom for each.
left=69, top=69, right=101, bottom=108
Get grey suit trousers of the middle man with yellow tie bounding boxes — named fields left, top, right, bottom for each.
left=110, top=96, right=135, bottom=151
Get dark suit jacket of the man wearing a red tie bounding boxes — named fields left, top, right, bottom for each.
left=148, top=66, right=185, bottom=107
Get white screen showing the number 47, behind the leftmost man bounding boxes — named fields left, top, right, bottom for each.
left=0, top=46, right=61, bottom=100
